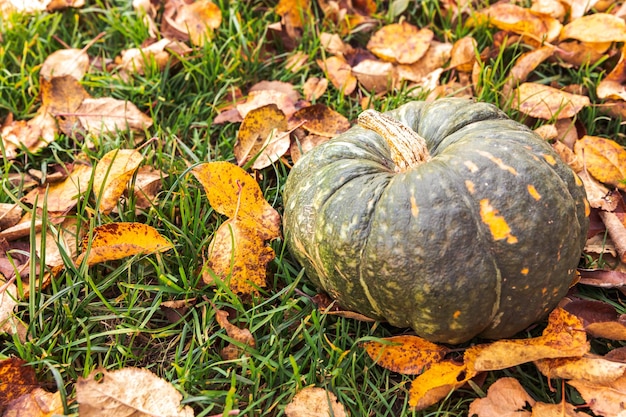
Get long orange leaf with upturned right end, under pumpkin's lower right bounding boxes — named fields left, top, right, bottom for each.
left=464, top=308, right=589, bottom=372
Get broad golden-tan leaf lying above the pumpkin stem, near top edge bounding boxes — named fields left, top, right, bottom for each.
left=367, top=22, right=434, bottom=64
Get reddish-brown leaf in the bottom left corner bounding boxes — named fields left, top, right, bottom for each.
left=0, top=358, right=39, bottom=415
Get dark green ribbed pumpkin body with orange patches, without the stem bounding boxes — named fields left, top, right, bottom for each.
left=284, top=99, right=589, bottom=343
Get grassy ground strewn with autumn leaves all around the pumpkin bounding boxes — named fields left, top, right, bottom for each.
left=0, top=0, right=626, bottom=417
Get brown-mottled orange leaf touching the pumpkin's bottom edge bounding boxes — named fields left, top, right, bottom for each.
left=363, top=336, right=449, bottom=375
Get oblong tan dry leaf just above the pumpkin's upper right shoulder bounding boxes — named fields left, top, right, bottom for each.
left=511, top=83, right=590, bottom=120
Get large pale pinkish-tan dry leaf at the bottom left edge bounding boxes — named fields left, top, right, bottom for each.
left=76, top=368, right=194, bottom=417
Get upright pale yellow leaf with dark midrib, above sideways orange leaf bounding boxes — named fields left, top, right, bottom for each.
left=93, top=149, right=143, bottom=214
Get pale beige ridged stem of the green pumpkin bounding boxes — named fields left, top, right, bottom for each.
left=358, top=109, right=430, bottom=172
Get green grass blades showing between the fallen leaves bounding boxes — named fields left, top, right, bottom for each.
left=0, top=0, right=625, bottom=417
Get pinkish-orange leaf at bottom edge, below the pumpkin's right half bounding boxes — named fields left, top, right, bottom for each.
left=468, top=378, right=536, bottom=417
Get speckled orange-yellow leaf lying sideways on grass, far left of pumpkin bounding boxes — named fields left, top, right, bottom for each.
left=76, top=223, right=172, bottom=265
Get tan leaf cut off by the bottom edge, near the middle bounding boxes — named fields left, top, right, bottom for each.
left=285, top=387, right=347, bottom=417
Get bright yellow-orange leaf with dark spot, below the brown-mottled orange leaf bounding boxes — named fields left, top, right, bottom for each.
left=409, top=362, right=475, bottom=410
